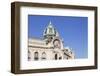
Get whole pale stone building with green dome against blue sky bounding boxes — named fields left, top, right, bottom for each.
left=28, top=22, right=75, bottom=61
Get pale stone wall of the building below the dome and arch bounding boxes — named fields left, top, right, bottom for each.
left=28, top=39, right=74, bottom=60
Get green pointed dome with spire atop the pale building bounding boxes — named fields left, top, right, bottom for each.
left=43, top=21, right=59, bottom=38
